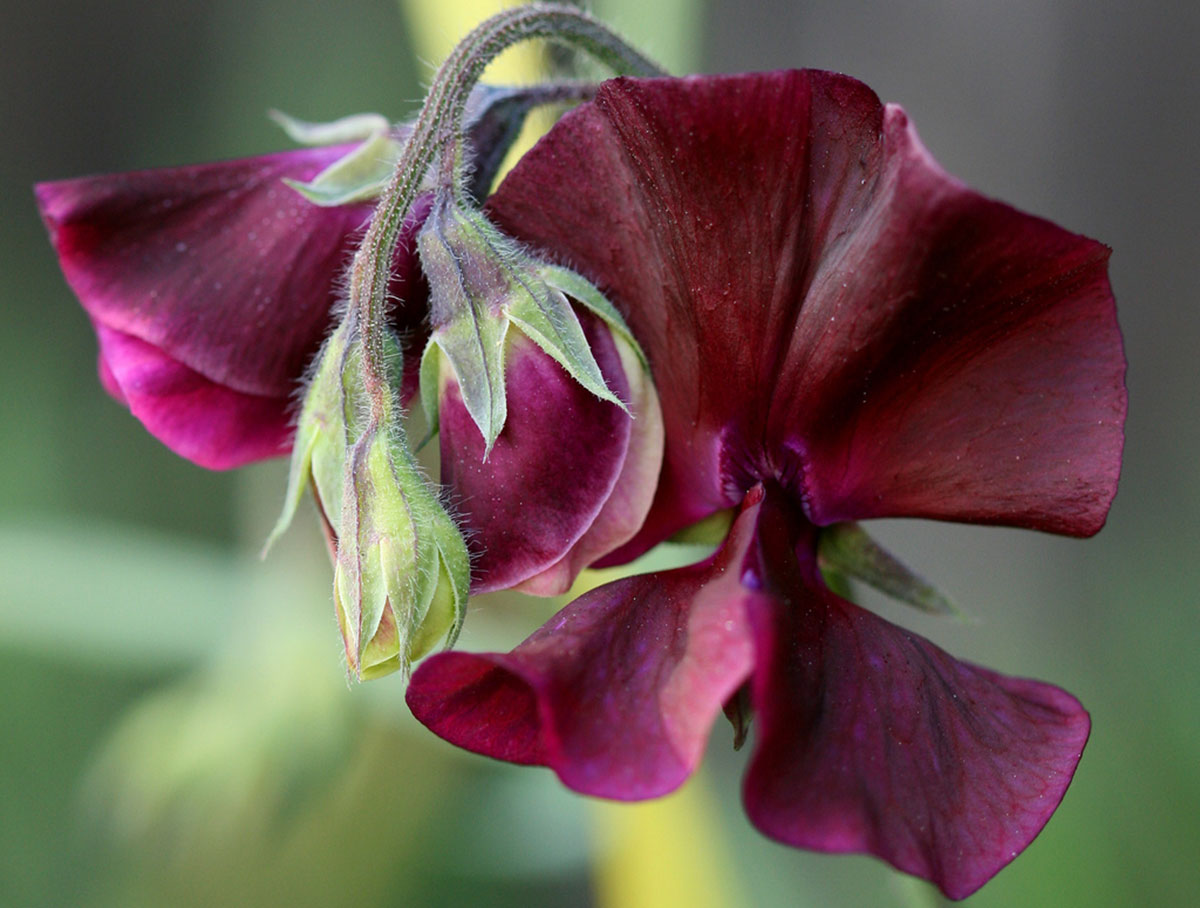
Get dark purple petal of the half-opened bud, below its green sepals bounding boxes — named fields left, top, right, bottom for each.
left=439, top=315, right=631, bottom=593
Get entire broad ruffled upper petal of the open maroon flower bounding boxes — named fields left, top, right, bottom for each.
left=491, top=71, right=1124, bottom=544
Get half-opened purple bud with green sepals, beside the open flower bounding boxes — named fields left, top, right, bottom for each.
left=418, top=193, right=662, bottom=595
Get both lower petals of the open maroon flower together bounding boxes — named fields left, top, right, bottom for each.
left=408, top=486, right=1090, bottom=898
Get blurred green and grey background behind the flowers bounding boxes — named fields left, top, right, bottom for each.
left=0, top=0, right=1200, bottom=908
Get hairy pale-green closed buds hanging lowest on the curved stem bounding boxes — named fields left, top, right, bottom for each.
left=268, top=320, right=469, bottom=680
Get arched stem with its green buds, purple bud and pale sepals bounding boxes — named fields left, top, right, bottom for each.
left=269, top=5, right=662, bottom=679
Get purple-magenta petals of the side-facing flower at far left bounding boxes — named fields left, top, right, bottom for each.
left=36, top=146, right=428, bottom=467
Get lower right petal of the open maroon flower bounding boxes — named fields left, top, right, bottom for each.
left=744, top=484, right=1088, bottom=898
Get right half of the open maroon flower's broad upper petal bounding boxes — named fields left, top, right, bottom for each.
left=772, top=106, right=1126, bottom=535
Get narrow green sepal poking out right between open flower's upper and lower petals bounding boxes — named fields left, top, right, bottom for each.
left=817, top=523, right=964, bottom=618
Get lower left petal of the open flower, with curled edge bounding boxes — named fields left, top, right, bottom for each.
left=408, top=489, right=756, bottom=800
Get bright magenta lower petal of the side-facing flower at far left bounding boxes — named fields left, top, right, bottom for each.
left=96, top=325, right=292, bottom=470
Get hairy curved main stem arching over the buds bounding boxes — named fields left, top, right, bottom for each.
left=346, top=4, right=666, bottom=434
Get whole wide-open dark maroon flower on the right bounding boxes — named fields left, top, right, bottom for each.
left=408, top=72, right=1126, bottom=898
